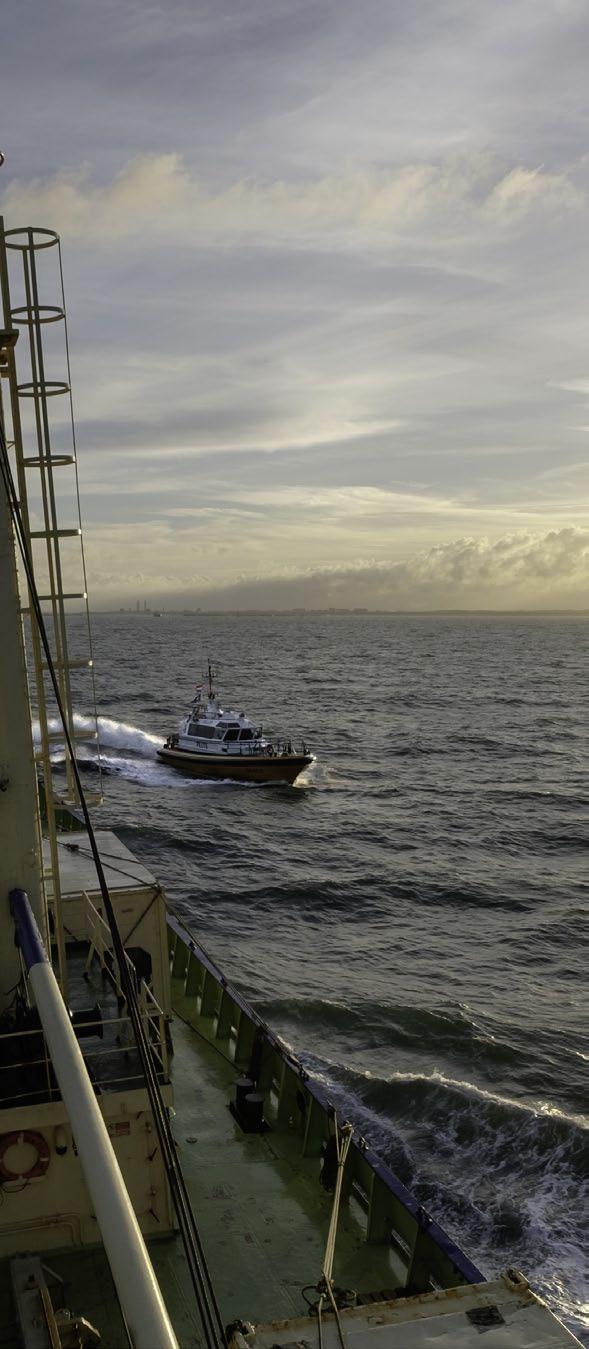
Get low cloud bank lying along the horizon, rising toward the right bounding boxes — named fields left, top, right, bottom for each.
left=85, top=527, right=589, bottom=611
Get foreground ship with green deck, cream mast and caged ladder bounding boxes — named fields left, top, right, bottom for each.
left=0, top=215, right=574, bottom=1349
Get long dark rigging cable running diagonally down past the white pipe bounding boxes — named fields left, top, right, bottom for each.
left=0, top=420, right=226, bottom=1349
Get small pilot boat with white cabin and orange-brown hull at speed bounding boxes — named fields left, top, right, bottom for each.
left=158, top=661, right=313, bottom=782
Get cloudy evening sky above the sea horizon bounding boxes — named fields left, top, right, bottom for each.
left=0, top=0, right=589, bottom=610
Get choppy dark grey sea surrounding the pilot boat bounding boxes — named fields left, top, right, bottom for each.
left=60, top=612, right=589, bottom=1345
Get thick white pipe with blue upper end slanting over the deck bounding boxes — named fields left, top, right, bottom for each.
left=11, top=890, right=178, bottom=1349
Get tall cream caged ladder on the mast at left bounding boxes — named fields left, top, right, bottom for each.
left=0, top=217, right=102, bottom=996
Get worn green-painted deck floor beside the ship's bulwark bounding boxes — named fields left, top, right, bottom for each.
left=165, top=1020, right=395, bottom=1322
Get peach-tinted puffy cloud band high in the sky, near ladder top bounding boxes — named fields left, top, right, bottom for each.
left=3, top=152, right=585, bottom=243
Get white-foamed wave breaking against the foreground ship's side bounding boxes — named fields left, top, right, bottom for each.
left=297, top=1055, right=589, bottom=1336
